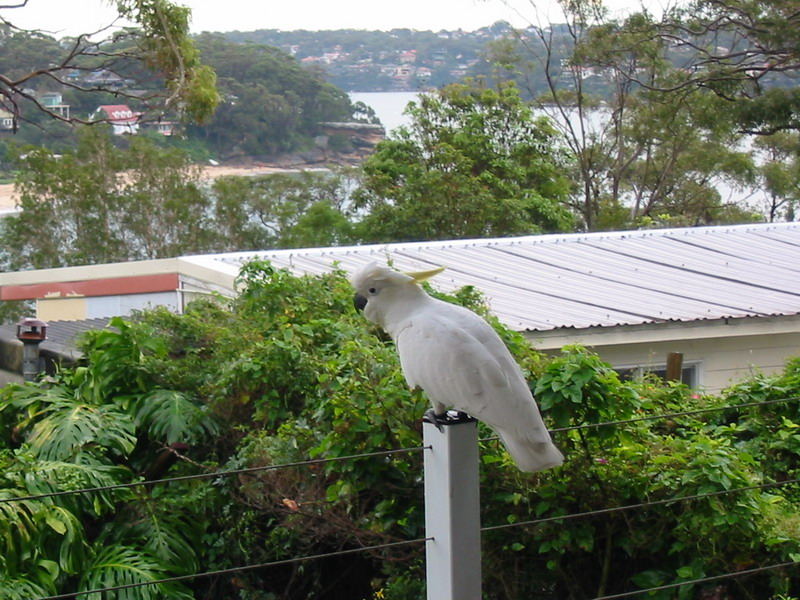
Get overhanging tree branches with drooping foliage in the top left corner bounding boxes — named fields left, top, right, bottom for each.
left=0, top=0, right=219, bottom=131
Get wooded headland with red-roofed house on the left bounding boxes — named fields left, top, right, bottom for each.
left=0, top=30, right=362, bottom=165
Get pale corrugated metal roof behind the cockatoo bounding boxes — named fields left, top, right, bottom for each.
left=187, top=223, right=800, bottom=331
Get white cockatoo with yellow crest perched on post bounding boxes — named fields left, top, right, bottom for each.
left=351, top=263, right=564, bottom=472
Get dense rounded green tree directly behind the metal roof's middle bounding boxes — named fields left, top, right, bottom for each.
left=355, top=82, right=572, bottom=241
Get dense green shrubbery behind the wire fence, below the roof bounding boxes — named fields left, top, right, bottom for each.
left=0, top=263, right=800, bottom=600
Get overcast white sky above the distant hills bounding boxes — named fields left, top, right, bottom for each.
left=0, top=0, right=669, bottom=37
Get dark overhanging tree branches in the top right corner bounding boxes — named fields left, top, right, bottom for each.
left=620, top=0, right=800, bottom=134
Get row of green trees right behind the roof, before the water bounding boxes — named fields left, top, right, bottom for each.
left=0, top=69, right=784, bottom=278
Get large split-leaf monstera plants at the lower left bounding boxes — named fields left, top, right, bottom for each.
left=0, top=319, right=216, bottom=600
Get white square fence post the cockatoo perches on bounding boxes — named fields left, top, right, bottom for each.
left=422, top=419, right=481, bottom=600
